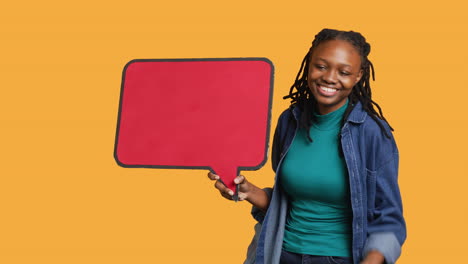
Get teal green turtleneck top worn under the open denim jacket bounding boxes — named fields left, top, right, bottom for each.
left=280, top=102, right=352, bottom=257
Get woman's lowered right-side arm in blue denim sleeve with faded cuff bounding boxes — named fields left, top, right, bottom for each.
left=363, top=122, right=406, bottom=264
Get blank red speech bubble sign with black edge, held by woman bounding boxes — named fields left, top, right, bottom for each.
left=114, top=58, right=273, bottom=190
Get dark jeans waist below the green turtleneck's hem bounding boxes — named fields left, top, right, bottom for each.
left=280, top=249, right=353, bottom=264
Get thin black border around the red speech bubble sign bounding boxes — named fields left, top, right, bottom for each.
left=114, top=57, right=275, bottom=175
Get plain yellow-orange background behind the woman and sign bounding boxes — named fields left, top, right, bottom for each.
left=0, top=0, right=468, bottom=264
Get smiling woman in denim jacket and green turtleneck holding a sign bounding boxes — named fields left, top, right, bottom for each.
left=208, top=29, right=406, bottom=264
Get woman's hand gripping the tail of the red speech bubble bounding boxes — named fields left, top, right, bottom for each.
left=208, top=172, right=270, bottom=211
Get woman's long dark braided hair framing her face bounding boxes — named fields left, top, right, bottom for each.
left=283, top=29, right=393, bottom=141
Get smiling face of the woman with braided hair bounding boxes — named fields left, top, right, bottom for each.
left=308, top=40, right=362, bottom=115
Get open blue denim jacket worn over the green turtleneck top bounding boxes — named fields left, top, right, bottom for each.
left=245, top=103, right=406, bottom=264
